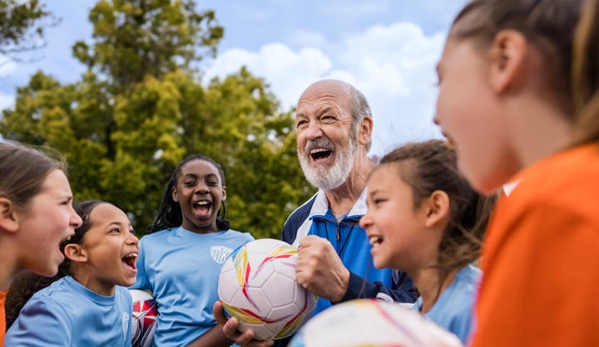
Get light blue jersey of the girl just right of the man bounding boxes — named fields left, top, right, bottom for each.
left=414, top=265, right=482, bottom=344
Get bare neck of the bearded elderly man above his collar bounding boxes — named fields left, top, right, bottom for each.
left=324, top=155, right=376, bottom=214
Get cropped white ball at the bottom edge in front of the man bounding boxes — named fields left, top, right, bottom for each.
left=288, top=299, right=462, bottom=347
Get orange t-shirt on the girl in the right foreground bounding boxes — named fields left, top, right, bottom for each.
left=471, top=145, right=599, bottom=347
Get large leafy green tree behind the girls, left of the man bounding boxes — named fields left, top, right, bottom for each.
left=0, top=0, right=314, bottom=238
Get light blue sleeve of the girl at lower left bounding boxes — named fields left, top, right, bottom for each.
left=5, top=297, right=73, bottom=347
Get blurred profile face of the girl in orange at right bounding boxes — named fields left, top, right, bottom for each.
left=435, top=34, right=517, bottom=193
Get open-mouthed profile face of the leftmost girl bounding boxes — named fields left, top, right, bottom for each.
left=17, top=169, right=81, bottom=276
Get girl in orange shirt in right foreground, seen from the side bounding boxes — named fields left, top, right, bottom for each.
left=435, top=0, right=599, bottom=347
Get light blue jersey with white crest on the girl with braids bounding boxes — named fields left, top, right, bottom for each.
left=131, top=227, right=254, bottom=347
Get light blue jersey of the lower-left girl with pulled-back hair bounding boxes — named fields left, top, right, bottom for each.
left=4, top=276, right=133, bottom=347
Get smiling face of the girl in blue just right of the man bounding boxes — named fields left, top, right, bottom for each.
left=360, top=161, right=439, bottom=274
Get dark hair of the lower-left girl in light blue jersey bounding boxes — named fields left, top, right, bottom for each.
left=5, top=200, right=106, bottom=329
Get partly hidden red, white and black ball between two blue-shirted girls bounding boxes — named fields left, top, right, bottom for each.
left=129, top=289, right=158, bottom=347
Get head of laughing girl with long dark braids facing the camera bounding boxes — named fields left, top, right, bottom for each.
left=173, top=159, right=226, bottom=233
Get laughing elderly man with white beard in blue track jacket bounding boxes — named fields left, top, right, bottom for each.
left=214, top=80, right=415, bottom=347
